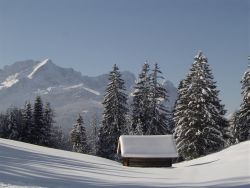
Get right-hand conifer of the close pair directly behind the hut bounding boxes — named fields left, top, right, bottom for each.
left=146, top=63, right=173, bottom=135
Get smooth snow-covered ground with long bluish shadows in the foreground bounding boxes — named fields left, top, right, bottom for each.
left=0, top=139, right=250, bottom=188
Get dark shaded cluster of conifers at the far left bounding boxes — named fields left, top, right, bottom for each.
left=0, top=96, right=66, bottom=149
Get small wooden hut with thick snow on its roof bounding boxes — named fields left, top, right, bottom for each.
left=117, top=135, right=178, bottom=167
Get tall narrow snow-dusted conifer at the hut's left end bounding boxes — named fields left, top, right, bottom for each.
left=97, top=64, right=128, bottom=159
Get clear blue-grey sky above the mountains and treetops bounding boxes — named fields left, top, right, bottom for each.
left=0, top=0, right=250, bottom=111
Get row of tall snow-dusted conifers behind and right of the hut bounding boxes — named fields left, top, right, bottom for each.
left=70, top=52, right=250, bottom=160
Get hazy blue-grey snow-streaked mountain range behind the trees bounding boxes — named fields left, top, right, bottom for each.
left=0, top=59, right=177, bottom=131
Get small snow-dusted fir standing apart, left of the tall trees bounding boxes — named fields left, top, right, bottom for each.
left=70, top=114, right=89, bottom=153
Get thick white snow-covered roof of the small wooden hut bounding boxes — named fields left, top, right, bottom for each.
left=117, top=135, right=178, bottom=158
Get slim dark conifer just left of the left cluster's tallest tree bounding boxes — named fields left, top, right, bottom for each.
left=21, top=102, right=34, bottom=143
